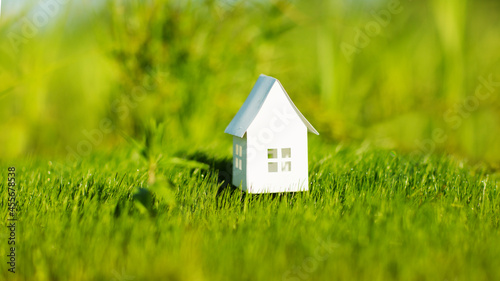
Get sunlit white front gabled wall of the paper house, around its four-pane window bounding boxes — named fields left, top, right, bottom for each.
left=246, top=83, right=309, bottom=193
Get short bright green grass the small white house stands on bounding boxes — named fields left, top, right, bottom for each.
left=0, top=141, right=500, bottom=280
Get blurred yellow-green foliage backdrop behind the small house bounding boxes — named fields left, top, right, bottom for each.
left=0, top=0, right=500, bottom=162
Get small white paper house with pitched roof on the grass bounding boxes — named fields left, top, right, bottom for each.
left=225, top=75, right=319, bottom=193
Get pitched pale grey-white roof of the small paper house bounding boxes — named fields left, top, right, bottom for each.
left=224, top=74, right=319, bottom=138
